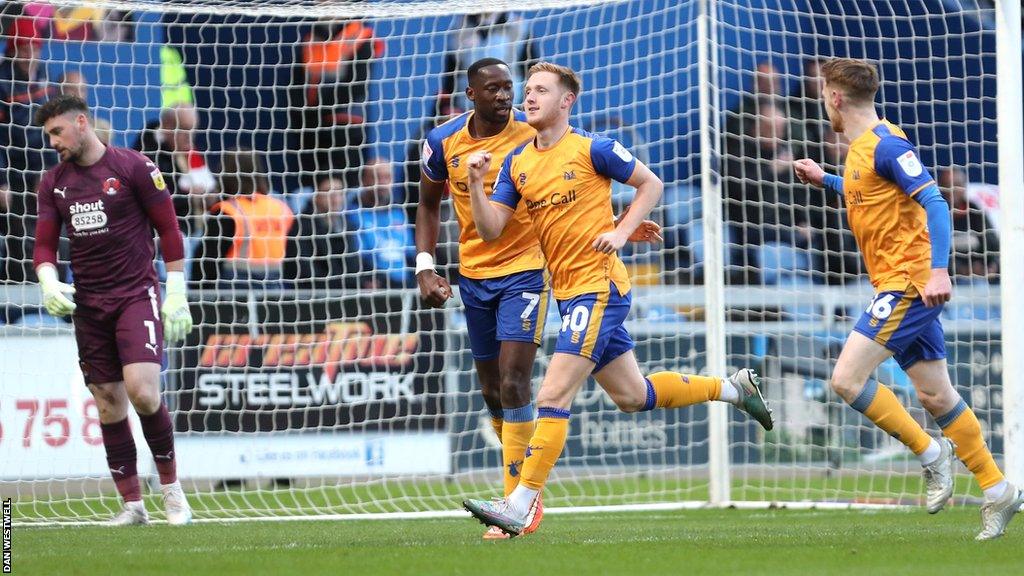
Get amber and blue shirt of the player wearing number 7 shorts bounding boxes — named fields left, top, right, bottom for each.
left=422, top=111, right=544, bottom=280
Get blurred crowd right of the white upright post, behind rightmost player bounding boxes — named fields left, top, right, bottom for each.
left=721, top=58, right=998, bottom=285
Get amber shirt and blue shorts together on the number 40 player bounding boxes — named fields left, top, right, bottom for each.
left=490, top=128, right=636, bottom=372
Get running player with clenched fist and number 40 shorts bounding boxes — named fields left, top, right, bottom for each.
left=464, top=63, right=772, bottom=536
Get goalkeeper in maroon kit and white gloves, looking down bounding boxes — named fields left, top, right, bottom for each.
left=33, top=95, right=193, bottom=526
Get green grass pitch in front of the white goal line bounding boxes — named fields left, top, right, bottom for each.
left=12, top=506, right=1024, bottom=576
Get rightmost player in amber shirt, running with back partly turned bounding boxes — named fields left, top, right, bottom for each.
left=794, top=58, right=1024, bottom=540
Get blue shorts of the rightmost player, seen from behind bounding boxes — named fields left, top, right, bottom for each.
left=853, top=286, right=946, bottom=370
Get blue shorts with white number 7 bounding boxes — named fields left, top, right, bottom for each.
left=459, top=270, right=549, bottom=360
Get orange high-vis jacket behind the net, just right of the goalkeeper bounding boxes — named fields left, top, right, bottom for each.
left=211, top=194, right=295, bottom=269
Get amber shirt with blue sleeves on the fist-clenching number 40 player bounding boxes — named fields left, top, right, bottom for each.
left=490, top=128, right=636, bottom=300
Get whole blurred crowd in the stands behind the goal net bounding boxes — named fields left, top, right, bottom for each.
left=0, top=2, right=998, bottom=313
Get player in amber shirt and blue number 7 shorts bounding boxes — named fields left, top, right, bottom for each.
left=416, top=58, right=549, bottom=539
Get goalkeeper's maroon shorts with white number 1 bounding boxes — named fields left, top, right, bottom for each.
left=74, top=287, right=164, bottom=384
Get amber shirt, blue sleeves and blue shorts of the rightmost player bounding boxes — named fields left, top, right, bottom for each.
left=825, top=120, right=950, bottom=369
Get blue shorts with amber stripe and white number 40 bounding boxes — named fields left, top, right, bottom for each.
left=555, top=282, right=635, bottom=372
